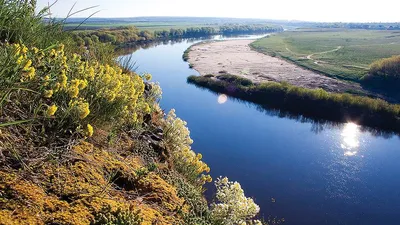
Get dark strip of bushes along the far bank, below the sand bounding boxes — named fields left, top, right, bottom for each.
left=188, top=75, right=400, bottom=132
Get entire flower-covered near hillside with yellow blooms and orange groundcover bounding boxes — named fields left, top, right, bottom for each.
left=0, top=0, right=272, bottom=225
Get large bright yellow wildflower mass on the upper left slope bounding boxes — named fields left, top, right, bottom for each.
left=0, top=44, right=151, bottom=139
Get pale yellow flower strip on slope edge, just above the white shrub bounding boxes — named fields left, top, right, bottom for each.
left=164, top=109, right=212, bottom=184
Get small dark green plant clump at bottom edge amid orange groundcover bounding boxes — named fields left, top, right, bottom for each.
left=92, top=207, right=143, bottom=225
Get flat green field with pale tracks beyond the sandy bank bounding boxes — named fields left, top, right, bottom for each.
left=252, top=29, right=400, bottom=81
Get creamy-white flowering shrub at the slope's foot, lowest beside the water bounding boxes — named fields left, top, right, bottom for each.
left=211, top=177, right=262, bottom=225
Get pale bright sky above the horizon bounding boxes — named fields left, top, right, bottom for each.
left=38, top=0, right=400, bottom=22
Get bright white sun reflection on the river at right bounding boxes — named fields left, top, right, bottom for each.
left=341, top=123, right=360, bottom=156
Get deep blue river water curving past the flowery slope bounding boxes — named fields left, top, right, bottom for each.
left=123, top=37, right=400, bottom=225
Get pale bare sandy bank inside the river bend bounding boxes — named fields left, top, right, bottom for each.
left=189, top=40, right=362, bottom=92
